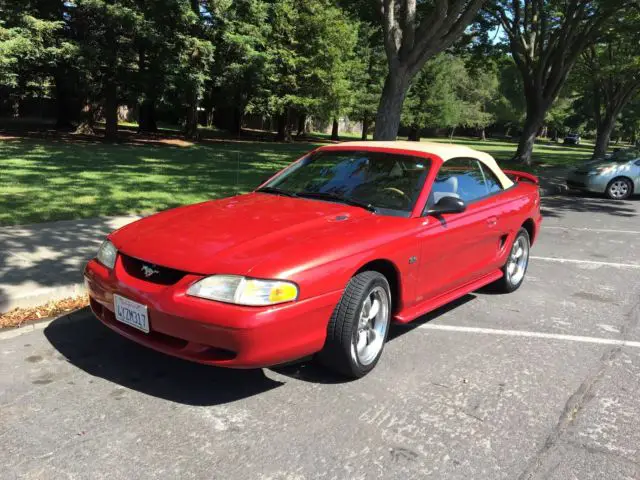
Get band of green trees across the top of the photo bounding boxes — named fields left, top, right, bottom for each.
left=0, top=0, right=640, bottom=155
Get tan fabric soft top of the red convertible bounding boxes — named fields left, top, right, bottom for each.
left=336, top=141, right=513, bottom=188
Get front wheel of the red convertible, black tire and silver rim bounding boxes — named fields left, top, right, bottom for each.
left=318, top=271, right=391, bottom=378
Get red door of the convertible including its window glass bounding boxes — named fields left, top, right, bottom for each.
left=417, top=158, right=504, bottom=301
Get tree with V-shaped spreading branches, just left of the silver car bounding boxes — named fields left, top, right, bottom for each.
left=489, top=0, right=625, bottom=164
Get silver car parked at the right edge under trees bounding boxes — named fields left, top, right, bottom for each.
left=567, top=148, right=640, bottom=200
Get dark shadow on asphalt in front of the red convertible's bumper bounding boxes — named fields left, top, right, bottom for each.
left=44, top=308, right=283, bottom=406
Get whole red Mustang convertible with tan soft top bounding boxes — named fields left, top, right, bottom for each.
left=85, top=142, right=541, bottom=377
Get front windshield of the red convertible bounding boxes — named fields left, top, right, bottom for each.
left=264, top=151, right=429, bottom=216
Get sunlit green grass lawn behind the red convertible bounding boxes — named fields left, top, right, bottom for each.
left=0, top=133, right=589, bottom=225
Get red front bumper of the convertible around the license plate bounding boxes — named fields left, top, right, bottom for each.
left=84, top=256, right=342, bottom=368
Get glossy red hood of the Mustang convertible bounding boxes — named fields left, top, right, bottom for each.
left=109, top=193, right=377, bottom=275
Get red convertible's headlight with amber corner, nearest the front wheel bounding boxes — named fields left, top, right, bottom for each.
left=187, top=275, right=298, bottom=306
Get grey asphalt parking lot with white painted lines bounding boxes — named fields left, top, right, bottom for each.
left=0, top=192, right=640, bottom=480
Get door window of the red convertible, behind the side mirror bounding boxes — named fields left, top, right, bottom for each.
left=428, top=158, right=489, bottom=206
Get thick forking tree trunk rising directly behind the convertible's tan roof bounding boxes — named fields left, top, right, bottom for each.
left=374, top=0, right=485, bottom=140
